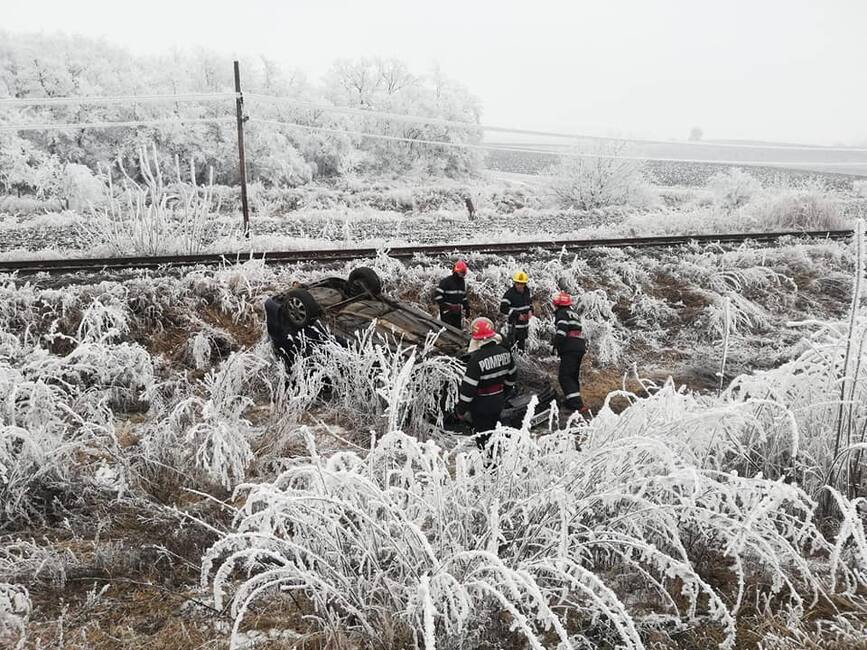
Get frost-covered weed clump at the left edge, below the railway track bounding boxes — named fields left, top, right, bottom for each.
left=0, top=291, right=154, bottom=526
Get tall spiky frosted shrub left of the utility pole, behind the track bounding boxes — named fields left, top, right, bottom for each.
left=80, top=146, right=216, bottom=255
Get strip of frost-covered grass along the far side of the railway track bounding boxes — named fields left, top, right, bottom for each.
left=0, top=166, right=867, bottom=258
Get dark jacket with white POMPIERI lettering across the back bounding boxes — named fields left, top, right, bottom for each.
left=457, top=342, right=515, bottom=414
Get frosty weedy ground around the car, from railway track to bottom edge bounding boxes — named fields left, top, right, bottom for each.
left=0, top=210, right=867, bottom=648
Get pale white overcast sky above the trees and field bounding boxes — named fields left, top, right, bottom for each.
left=6, top=0, right=867, bottom=144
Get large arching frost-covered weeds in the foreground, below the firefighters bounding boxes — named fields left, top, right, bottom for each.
left=202, top=389, right=867, bottom=648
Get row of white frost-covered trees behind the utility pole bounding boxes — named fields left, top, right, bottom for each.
left=0, top=33, right=480, bottom=196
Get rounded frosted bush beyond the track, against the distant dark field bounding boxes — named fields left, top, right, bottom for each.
left=551, top=146, right=656, bottom=210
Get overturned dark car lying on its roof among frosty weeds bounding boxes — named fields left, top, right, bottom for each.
left=265, top=267, right=555, bottom=429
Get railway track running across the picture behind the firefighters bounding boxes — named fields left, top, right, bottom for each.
left=0, top=230, right=852, bottom=274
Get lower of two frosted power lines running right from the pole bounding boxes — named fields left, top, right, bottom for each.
left=244, top=118, right=867, bottom=167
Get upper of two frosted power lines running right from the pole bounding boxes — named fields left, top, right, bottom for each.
left=245, top=93, right=867, bottom=153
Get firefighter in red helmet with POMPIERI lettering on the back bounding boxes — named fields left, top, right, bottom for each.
left=457, top=318, right=515, bottom=449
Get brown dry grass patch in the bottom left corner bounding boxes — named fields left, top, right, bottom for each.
left=17, top=492, right=237, bottom=649
